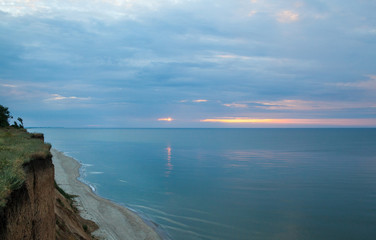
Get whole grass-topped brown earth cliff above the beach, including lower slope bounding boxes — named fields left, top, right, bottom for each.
left=0, top=129, right=97, bottom=240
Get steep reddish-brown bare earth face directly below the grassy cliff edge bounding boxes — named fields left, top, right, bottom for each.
left=0, top=156, right=56, bottom=240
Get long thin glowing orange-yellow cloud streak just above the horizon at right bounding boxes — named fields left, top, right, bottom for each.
left=200, top=118, right=376, bottom=126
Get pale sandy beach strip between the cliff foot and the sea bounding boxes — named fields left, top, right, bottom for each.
left=51, top=149, right=162, bottom=240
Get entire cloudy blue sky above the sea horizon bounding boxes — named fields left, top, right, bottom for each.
left=0, top=0, right=376, bottom=128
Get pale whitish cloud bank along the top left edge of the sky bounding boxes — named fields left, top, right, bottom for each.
left=0, top=0, right=191, bottom=23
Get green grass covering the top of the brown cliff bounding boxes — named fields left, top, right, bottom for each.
left=0, top=128, right=51, bottom=208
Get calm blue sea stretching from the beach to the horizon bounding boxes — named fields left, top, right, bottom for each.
left=31, top=128, right=376, bottom=240
